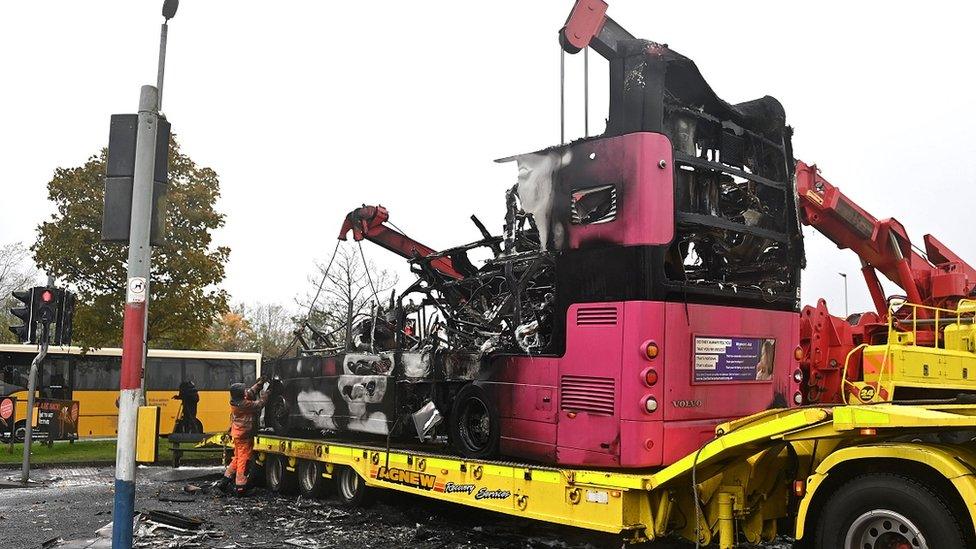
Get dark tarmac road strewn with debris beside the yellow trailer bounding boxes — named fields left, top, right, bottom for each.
left=0, top=467, right=789, bottom=549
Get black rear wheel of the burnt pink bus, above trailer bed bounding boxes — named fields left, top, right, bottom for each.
left=448, top=383, right=501, bottom=459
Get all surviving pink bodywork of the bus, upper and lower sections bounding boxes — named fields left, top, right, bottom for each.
left=474, top=132, right=799, bottom=468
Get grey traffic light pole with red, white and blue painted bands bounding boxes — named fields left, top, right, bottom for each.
left=112, top=86, right=159, bottom=549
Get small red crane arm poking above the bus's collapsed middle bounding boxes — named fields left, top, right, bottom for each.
left=339, top=205, right=464, bottom=279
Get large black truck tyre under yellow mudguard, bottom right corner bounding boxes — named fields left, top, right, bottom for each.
left=815, top=473, right=966, bottom=549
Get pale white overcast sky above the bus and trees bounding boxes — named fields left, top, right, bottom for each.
left=0, top=0, right=976, bottom=313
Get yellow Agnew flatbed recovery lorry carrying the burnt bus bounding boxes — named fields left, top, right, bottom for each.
left=202, top=402, right=976, bottom=549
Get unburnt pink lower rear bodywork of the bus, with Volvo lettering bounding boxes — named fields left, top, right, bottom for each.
left=486, top=301, right=799, bottom=468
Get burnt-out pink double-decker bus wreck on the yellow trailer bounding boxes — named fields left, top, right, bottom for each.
left=265, top=29, right=803, bottom=467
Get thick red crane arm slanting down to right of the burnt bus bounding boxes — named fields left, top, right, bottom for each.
left=796, top=162, right=976, bottom=317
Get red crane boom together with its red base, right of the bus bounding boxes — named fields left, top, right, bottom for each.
left=796, top=161, right=976, bottom=403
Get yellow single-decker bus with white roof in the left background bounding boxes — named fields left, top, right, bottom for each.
left=0, top=345, right=261, bottom=438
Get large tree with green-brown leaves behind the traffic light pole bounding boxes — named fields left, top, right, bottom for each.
left=31, top=138, right=230, bottom=349
